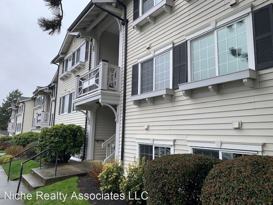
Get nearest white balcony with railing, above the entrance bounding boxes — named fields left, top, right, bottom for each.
left=74, top=62, right=120, bottom=109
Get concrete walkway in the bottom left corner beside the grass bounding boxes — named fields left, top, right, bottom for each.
left=0, top=166, right=28, bottom=205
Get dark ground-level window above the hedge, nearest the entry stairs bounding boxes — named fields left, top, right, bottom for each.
left=139, top=144, right=171, bottom=160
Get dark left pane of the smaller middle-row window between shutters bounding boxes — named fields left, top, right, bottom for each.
left=141, top=59, right=153, bottom=93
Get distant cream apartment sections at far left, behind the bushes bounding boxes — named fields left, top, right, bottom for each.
left=8, top=73, right=57, bottom=136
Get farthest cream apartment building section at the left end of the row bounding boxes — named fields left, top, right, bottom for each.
left=8, top=97, right=33, bottom=136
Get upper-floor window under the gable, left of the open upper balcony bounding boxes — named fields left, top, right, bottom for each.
left=62, top=43, right=88, bottom=73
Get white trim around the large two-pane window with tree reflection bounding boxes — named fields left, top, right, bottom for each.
left=186, top=8, right=255, bottom=82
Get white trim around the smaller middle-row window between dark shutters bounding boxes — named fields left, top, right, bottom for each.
left=135, top=43, right=173, bottom=96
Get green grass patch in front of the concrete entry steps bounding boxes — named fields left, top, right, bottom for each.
left=24, top=177, right=89, bottom=205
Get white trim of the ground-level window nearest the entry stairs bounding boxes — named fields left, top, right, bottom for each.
left=136, top=138, right=175, bottom=159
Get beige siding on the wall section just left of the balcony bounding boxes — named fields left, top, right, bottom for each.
left=55, top=38, right=89, bottom=127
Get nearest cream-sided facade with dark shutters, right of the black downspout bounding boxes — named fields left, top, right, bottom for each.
left=124, top=0, right=273, bottom=165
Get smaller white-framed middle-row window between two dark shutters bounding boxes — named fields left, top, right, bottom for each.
left=138, top=48, right=173, bottom=95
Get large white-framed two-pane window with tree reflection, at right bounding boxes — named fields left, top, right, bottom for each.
left=188, top=12, right=255, bottom=81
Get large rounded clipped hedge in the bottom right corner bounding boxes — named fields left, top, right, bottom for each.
left=201, top=156, right=273, bottom=205
